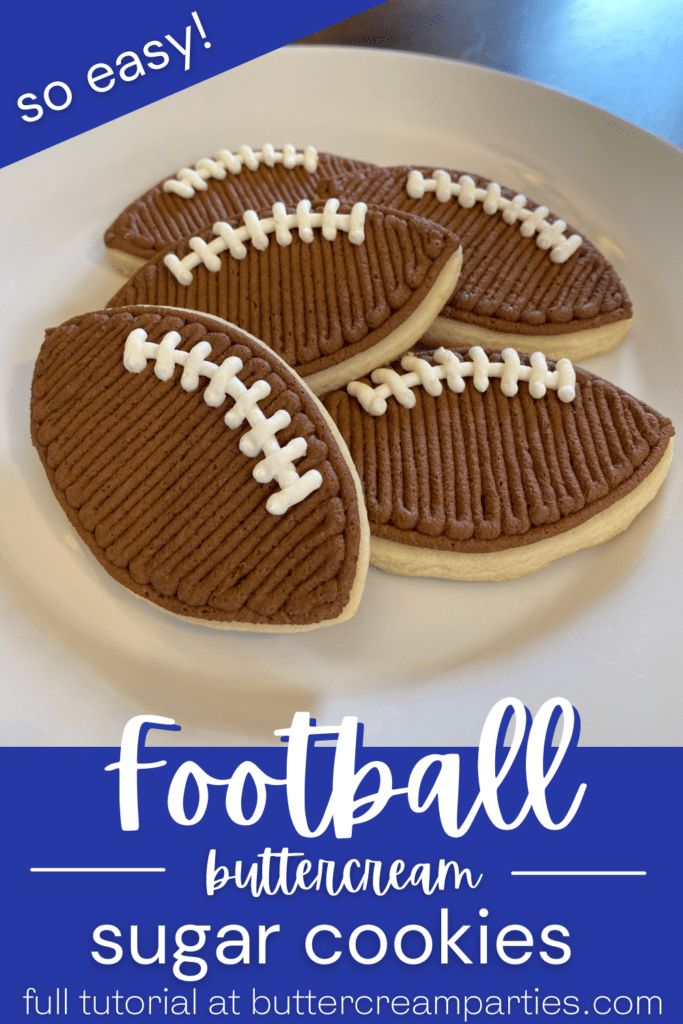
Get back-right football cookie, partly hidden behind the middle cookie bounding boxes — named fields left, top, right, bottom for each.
left=318, top=167, right=632, bottom=359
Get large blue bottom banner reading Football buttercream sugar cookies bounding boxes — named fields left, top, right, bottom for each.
left=0, top=701, right=683, bottom=1024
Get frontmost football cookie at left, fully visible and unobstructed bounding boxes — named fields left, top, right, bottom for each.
left=31, top=308, right=369, bottom=632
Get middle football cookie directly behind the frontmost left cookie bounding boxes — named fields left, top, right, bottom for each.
left=108, top=199, right=462, bottom=394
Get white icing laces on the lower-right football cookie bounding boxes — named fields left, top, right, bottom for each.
left=346, top=345, right=577, bottom=416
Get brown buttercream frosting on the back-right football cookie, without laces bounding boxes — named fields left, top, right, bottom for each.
left=318, top=166, right=633, bottom=335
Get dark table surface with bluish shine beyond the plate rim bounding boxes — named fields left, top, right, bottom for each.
left=302, top=0, right=683, bottom=145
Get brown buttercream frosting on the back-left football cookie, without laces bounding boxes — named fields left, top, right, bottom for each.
left=104, top=153, right=373, bottom=260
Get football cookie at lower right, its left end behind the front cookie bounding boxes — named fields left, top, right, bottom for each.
left=325, top=346, right=674, bottom=580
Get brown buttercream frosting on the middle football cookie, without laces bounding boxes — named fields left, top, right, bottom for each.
left=108, top=208, right=460, bottom=377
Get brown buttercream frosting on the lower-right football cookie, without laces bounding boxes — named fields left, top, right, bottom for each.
left=324, top=348, right=674, bottom=553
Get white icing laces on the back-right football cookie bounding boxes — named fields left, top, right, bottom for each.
left=405, top=171, right=584, bottom=263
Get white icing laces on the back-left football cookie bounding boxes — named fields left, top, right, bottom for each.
left=162, top=142, right=317, bottom=199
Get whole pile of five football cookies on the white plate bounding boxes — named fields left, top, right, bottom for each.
left=32, top=145, right=674, bottom=631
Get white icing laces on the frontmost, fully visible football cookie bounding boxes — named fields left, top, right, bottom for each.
left=123, top=328, right=323, bottom=515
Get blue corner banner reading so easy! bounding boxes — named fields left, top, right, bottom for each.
left=0, top=0, right=376, bottom=167
